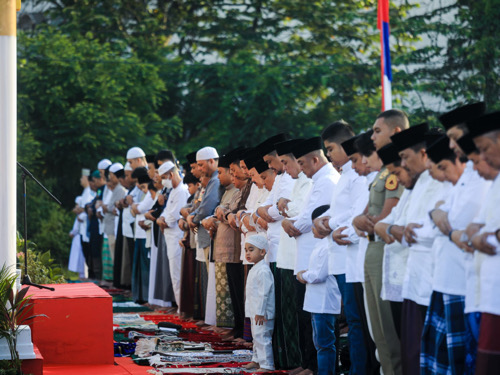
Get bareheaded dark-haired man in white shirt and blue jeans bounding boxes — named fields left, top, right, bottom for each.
left=315, top=121, right=368, bottom=374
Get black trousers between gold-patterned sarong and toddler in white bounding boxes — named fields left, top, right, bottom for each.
left=226, top=263, right=245, bottom=337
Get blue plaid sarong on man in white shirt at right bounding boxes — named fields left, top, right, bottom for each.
left=420, top=291, right=470, bottom=374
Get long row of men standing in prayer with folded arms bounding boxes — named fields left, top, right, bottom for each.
left=66, top=103, right=500, bottom=374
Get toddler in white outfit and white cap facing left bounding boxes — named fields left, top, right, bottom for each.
left=245, top=235, right=275, bottom=371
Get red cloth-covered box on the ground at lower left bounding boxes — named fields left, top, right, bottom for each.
left=28, top=283, right=114, bottom=366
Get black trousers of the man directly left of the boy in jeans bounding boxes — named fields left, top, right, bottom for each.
left=295, top=280, right=318, bottom=373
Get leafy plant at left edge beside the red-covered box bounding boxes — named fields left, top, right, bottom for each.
left=0, top=265, right=45, bottom=375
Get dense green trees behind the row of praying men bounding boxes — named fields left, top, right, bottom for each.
left=18, top=0, right=500, bottom=260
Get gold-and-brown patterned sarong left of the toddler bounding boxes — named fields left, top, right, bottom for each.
left=215, top=262, right=234, bottom=328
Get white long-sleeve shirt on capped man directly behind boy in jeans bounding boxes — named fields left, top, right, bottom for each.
left=291, top=163, right=340, bottom=275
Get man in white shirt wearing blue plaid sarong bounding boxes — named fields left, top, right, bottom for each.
left=421, top=103, right=491, bottom=374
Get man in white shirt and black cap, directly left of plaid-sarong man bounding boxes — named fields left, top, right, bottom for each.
left=391, top=123, right=448, bottom=374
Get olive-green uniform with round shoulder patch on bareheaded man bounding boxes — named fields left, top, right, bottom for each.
left=365, top=167, right=404, bottom=375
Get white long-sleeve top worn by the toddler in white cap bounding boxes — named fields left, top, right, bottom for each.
left=245, top=259, right=275, bottom=320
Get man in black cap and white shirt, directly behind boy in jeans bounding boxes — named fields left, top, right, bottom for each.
left=282, top=137, right=340, bottom=371
